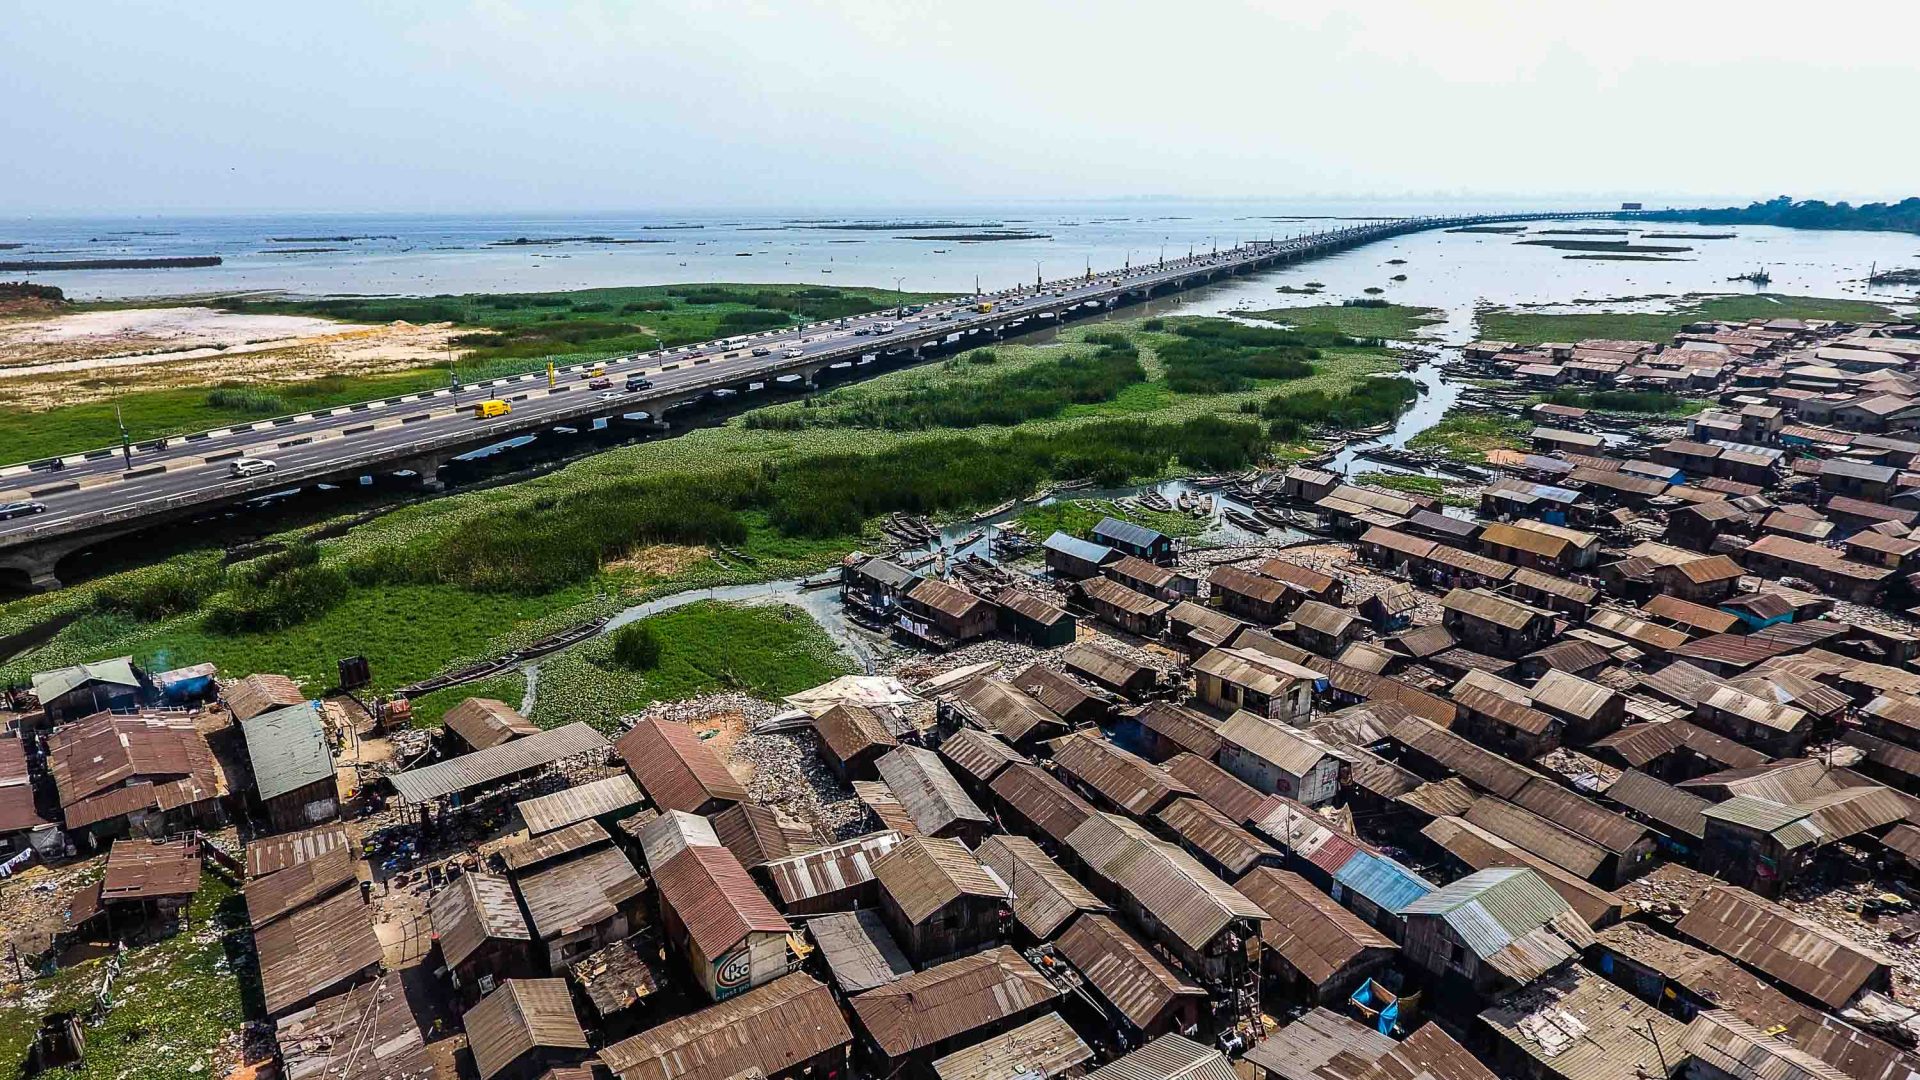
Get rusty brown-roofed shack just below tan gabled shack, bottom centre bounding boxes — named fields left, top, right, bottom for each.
left=849, top=945, right=1060, bottom=1076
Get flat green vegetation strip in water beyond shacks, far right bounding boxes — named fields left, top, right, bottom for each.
left=1478, top=292, right=1895, bottom=344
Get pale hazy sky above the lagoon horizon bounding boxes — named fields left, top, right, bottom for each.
left=0, top=0, right=1920, bottom=217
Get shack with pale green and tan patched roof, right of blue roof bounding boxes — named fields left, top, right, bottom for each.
left=1402, top=867, right=1594, bottom=995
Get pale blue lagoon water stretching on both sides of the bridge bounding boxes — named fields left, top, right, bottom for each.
left=0, top=202, right=1920, bottom=322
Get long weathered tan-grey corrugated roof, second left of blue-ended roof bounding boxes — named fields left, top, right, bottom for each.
left=1068, top=813, right=1267, bottom=949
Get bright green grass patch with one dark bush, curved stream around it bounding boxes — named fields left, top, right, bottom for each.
left=532, top=601, right=852, bottom=730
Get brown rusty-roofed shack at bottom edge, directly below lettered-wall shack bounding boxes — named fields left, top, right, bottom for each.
left=599, top=972, right=852, bottom=1080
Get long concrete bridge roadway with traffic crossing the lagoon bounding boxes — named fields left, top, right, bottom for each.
left=0, top=211, right=1632, bottom=588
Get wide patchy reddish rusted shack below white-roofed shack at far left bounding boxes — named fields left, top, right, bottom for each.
left=46, top=713, right=225, bottom=840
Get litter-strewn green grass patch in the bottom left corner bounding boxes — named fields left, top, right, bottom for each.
left=0, top=874, right=247, bottom=1080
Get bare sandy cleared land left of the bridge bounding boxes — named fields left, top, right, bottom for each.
left=0, top=307, right=459, bottom=409
